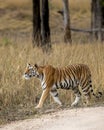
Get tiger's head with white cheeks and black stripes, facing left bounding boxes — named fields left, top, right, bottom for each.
left=23, top=64, right=40, bottom=79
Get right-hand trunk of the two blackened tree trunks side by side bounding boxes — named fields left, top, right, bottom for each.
left=41, top=0, right=51, bottom=47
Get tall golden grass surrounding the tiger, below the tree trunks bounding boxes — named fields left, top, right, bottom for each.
left=0, top=43, right=104, bottom=108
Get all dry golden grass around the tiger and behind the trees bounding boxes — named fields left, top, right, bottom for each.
left=0, top=0, right=104, bottom=124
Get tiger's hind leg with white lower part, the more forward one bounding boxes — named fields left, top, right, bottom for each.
left=71, top=87, right=81, bottom=107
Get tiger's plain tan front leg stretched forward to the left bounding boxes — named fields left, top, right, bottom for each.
left=35, top=88, right=50, bottom=108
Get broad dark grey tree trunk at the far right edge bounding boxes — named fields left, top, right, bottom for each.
left=91, top=0, right=104, bottom=41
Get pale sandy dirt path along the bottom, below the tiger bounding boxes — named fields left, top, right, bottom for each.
left=0, top=107, right=104, bottom=130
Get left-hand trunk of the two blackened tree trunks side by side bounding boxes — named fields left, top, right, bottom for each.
left=33, top=0, right=41, bottom=46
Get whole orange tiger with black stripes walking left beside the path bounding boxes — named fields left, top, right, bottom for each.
left=23, top=64, right=102, bottom=108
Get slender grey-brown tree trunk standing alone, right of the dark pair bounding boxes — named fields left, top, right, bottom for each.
left=63, top=0, right=72, bottom=43
